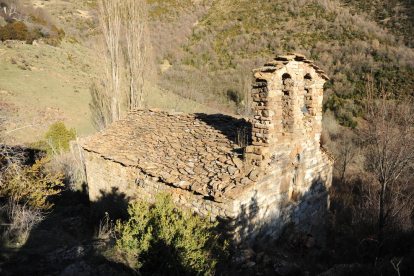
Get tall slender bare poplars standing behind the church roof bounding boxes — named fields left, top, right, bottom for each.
left=91, top=0, right=150, bottom=129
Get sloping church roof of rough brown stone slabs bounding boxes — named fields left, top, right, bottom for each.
left=83, top=109, right=259, bottom=199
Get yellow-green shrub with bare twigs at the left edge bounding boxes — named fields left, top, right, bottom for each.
left=0, top=144, right=63, bottom=243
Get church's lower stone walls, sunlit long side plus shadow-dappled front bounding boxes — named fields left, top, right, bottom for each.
left=84, top=144, right=331, bottom=244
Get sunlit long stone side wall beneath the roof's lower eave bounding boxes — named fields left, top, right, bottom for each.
left=84, top=151, right=237, bottom=234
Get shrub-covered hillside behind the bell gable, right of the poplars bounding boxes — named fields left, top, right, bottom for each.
left=148, top=0, right=414, bottom=122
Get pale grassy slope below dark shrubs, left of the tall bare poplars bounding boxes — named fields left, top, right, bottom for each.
left=0, top=41, right=95, bottom=141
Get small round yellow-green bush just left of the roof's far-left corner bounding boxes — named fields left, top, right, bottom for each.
left=45, top=122, right=76, bottom=155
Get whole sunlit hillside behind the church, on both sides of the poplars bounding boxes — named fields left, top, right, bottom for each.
left=0, top=0, right=414, bottom=141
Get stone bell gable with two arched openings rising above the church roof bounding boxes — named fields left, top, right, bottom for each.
left=246, top=53, right=329, bottom=202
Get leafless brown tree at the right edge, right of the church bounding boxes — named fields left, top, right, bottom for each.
left=361, top=94, right=414, bottom=248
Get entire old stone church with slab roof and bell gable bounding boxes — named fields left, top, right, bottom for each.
left=82, top=54, right=333, bottom=243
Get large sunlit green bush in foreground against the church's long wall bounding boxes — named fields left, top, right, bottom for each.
left=116, top=194, right=226, bottom=275
